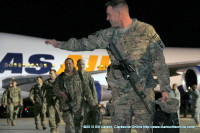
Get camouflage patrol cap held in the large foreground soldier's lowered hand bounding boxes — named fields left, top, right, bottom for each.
left=154, top=98, right=179, bottom=113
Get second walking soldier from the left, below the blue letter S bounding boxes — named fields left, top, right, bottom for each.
left=29, top=76, right=46, bottom=130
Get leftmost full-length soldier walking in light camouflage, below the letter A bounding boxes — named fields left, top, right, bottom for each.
left=7, top=80, right=23, bottom=126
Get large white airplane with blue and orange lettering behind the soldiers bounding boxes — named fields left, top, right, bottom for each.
left=0, top=32, right=200, bottom=115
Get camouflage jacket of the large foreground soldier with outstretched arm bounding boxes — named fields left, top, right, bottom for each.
left=60, top=19, right=170, bottom=92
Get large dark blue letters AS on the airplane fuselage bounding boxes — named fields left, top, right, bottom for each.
left=0, top=53, right=54, bottom=74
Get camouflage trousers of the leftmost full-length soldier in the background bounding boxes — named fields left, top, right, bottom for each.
left=7, top=103, right=19, bottom=122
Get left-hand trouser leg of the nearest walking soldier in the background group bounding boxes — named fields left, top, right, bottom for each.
left=62, top=111, right=75, bottom=133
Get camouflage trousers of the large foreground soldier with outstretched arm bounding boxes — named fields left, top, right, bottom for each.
left=107, top=70, right=155, bottom=133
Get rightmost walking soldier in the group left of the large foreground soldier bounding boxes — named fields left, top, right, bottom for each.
left=75, top=59, right=99, bottom=133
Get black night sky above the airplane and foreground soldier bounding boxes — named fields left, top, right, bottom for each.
left=0, top=0, right=200, bottom=47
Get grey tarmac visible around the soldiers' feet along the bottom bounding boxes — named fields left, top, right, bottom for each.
left=0, top=116, right=200, bottom=133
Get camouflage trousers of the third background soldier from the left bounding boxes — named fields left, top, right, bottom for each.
left=47, top=103, right=62, bottom=129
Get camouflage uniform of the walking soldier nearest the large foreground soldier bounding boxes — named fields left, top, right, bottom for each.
left=74, top=71, right=98, bottom=133
